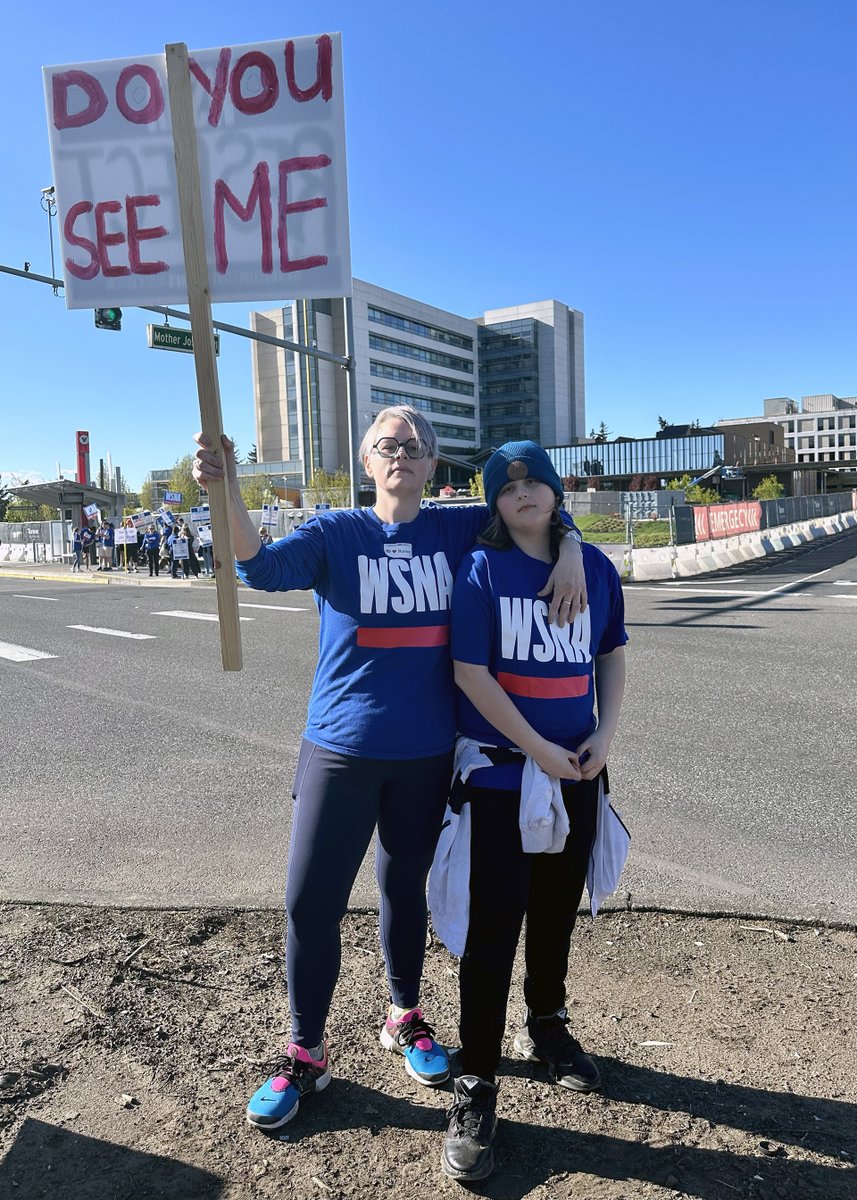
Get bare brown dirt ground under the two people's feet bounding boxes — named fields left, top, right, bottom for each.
left=0, top=904, right=857, bottom=1200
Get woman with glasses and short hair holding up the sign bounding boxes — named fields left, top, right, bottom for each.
left=193, top=406, right=585, bottom=1129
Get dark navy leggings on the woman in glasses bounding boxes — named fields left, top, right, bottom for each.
left=286, top=740, right=453, bottom=1046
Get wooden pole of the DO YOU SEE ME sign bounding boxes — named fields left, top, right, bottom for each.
left=164, top=42, right=241, bottom=671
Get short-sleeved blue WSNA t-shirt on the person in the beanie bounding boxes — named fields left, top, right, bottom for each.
left=453, top=544, right=628, bottom=787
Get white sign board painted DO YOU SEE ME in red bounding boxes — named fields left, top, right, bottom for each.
left=43, top=34, right=352, bottom=308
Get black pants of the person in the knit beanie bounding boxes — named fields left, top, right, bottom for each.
left=460, top=780, right=598, bottom=1080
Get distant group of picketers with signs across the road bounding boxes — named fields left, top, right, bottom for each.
left=71, top=517, right=214, bottom=580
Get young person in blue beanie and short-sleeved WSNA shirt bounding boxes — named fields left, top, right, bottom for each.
left=432, top=442, right=627, bottom=1183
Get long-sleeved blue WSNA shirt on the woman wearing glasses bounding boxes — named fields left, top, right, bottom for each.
left=238, top=505, right=487, bottom=760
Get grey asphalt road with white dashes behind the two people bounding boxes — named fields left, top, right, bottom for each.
left=0, top=533, right=857, bottom=924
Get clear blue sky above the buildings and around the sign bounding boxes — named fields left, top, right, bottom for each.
left=0, top=0, right=857, bottom=487
